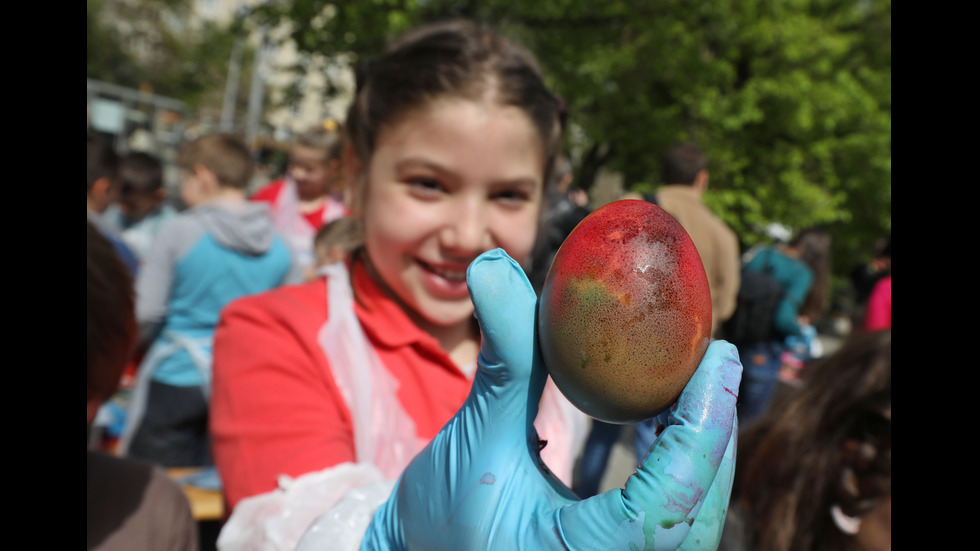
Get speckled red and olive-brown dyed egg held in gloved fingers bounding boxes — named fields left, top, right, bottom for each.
left=538, top=199, right=711, bottom=423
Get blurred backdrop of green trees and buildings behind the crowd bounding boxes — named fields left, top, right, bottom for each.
left=86, top=0, right=891, bottom=336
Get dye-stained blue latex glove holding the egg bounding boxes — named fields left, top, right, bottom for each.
left=361, top=249, right=742, bottom=550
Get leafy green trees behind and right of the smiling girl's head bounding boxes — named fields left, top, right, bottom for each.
left=243, top=0, right=891, bottom=282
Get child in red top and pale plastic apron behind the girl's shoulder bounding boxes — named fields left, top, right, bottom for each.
left=251, top=119, right=349, bottom=278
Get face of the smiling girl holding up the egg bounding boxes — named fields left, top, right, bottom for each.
left=363, top=99, right=544, bottom=327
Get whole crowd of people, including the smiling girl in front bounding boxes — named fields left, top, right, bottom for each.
left=88, top=16, right=891, bottom=551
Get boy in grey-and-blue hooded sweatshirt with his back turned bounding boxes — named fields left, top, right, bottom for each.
left=120, top=134, right=293, bottom=467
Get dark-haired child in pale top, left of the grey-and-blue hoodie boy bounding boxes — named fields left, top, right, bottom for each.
left=105, top=151, right=177, bottom=264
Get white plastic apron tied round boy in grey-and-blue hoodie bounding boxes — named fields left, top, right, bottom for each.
left=119, top=330, right=212, bottom=455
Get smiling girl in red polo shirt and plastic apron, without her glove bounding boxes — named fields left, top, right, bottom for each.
left=211, top=17, right=584, bottom=536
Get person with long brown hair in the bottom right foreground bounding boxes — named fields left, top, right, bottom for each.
left=719, top=330, right=892, bottom=551
